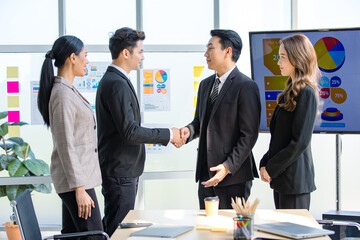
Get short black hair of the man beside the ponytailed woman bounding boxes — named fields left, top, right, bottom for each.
left=109, top=27, right=145, bottom=59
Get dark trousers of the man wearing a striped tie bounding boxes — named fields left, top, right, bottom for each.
left=198, top=181, right=252, bottom=209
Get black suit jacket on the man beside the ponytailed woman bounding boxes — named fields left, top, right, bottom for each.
left=96, top=66, right=170, bottom=177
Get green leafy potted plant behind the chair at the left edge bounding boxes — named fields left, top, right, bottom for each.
left=0, top=112, right=51, bottom=239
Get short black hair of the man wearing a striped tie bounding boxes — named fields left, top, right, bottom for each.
left=210, top=29, right=242, bottom=62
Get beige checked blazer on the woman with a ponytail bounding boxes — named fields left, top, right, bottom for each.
left=49, top=77, right=101, bottom=193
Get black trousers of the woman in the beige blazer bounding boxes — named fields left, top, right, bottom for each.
left=59, top=188, right=104, bottom=240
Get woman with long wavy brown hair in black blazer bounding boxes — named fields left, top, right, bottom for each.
left=260, top=34, right=320, bottom=209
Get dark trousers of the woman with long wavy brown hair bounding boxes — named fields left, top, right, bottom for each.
left=274, top=191, right=310, bottom=210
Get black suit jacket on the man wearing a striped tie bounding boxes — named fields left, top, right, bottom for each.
left=187, top=67, right=261, bottom=186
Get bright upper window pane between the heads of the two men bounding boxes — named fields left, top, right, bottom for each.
left=143, top=0, right=214, bottom=45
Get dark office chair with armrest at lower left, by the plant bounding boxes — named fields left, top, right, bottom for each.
left=10, top=189, right=109, bottom=240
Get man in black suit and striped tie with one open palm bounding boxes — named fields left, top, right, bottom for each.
left=180, top=29, right=261, bottom=209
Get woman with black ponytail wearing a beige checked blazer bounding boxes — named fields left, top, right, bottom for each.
left=38, top=36, right=103, bottom=239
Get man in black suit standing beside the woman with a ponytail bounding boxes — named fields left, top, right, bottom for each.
left=96, top=28, right=180, bottom=236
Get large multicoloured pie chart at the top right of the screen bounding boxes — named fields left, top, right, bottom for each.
left=314, top=37, right=345, bottom=73
